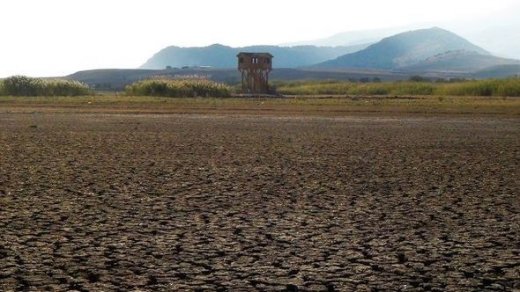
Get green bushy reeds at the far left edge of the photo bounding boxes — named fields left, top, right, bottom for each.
left=0, top=76, right=91, bottom=96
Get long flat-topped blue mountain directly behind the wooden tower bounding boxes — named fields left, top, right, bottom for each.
left=141, top=44, right=368, bottom=69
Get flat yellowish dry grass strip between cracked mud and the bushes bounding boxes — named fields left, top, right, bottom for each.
left=0, top=95, right=520, bottom=116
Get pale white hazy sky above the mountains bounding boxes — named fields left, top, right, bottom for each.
left=0, top=0, right=520, bottom=77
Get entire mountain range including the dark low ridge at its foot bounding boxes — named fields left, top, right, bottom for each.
left=68, top=27, right=520, bottom=90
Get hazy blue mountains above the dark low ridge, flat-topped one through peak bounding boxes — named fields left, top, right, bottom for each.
left=141, top=27, right=520, bottom=74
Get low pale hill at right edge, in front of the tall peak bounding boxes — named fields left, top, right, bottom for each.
left=400, top=50, right=520, bottom=73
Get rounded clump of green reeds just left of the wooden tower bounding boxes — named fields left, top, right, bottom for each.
left=125, top=79, right=231, bottom=97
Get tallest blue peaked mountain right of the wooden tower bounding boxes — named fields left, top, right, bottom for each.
left=315, top=27, right=489, bottom=70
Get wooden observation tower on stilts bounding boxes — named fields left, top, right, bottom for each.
left=237, top=52, right=273, bottom=93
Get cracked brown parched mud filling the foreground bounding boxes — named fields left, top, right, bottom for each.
left=0, top=107, right=520, bottom=291
